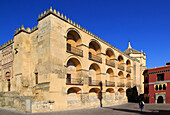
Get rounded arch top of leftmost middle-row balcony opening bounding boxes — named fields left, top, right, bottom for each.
left=66, top=58, right=82, bottom=70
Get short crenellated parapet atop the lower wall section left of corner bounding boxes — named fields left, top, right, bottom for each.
left=14, top=25, right=38, bottom=36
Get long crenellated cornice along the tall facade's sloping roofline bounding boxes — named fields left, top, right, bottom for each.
left=37, top=7, right=140, bottom=62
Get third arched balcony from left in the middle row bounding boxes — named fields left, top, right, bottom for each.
left=106, top=68, right=115, bottom=87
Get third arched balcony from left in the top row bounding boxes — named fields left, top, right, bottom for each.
left=106, top=49, right=115, bottom=67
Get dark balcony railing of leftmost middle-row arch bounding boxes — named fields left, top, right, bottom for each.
left=66, top=78, right=83, bottom=85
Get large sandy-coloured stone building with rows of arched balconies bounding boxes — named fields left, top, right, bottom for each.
left=0, top=8, right=146, bottom=112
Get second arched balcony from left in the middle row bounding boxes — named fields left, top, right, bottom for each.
left=89, top=63, right=101, bottom=86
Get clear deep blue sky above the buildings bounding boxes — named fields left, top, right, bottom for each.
left=0, top=0, right=170, bottom=68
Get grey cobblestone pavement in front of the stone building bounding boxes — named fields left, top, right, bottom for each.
left=0, top=103, right=170, bottom=115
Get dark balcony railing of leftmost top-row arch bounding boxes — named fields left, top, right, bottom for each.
left=67, top=43, right=83, bottom=57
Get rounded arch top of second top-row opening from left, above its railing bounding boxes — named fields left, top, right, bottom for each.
left=89, top=39, right=101, bottom=53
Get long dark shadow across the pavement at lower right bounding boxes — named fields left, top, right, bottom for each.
left=104, top=107, right=170, bottom=115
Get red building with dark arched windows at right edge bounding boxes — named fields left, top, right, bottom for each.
left=143, top=62, right=170, bottom=103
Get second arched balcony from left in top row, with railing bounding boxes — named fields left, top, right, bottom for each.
left=89, top=41, right=102, bottom=63
